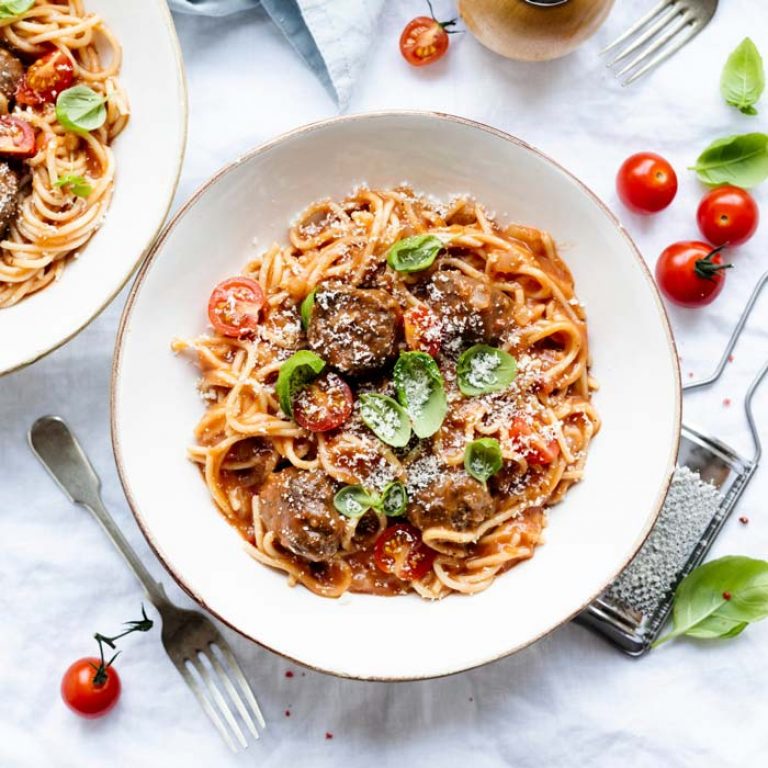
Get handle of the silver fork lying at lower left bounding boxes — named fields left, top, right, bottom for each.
left=29, top=416, right=168, bottom=608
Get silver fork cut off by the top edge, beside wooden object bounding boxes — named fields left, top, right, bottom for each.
left=601, top=0, right=718, bottom=85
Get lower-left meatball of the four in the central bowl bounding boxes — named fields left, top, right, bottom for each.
left=259, top=467, right=346, bottom=562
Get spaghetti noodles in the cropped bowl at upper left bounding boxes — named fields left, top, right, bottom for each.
left=0, top=0, right=129, bottom=308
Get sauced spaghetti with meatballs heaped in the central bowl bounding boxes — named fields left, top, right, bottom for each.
left=173, top=187, right=600, bottom=598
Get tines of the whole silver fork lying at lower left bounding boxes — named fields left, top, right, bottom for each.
left=169, top=642, right=267, bottom=752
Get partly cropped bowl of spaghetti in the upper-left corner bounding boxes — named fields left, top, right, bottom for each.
left=0, top=0, right=186, bottom=374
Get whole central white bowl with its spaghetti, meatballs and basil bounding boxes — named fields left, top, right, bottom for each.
left=112, top=113, right=680, bottom=680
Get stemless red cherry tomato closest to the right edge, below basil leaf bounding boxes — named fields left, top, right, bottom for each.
left=697, top=185, right=760, bottom=245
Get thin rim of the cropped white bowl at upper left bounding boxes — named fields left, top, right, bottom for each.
left=0, top=0, right=189, bottom=378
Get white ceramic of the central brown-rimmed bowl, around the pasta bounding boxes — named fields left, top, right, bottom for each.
left=112, top=113, right=680, bottom=679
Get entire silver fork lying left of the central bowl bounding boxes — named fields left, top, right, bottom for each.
left=29, top=416, right=267, bottom=752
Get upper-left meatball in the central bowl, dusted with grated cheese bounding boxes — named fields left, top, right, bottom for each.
left=307, top=285, right=400, bottom=375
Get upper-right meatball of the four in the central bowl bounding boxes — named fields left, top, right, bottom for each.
left=427, top=270, right=514, bottom=350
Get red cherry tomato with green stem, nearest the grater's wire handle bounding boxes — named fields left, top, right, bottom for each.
left=656, top=240, right=731, bottom=307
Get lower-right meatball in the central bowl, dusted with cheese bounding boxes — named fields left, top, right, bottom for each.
left=407, top=469, right=496, bottom=531
